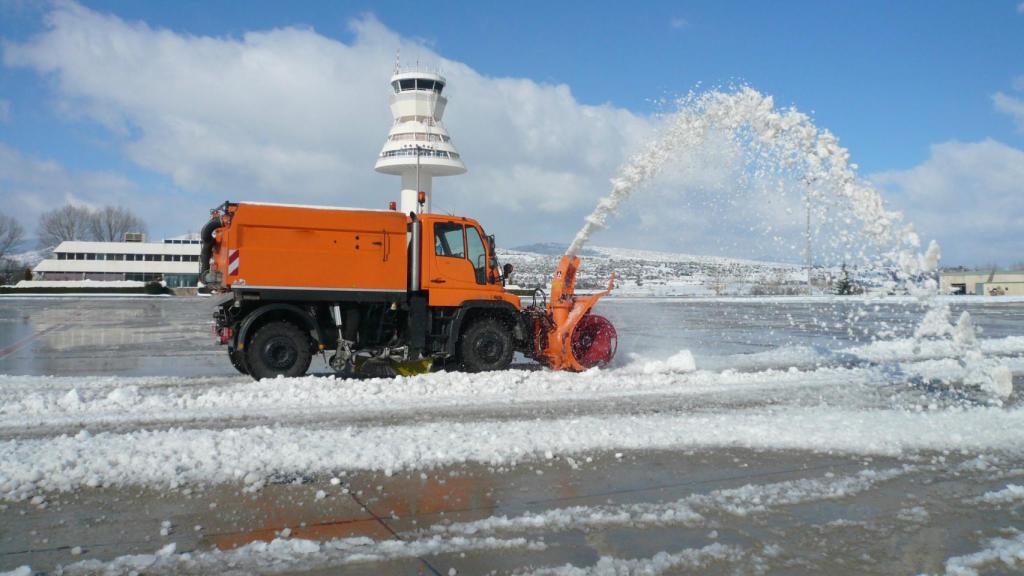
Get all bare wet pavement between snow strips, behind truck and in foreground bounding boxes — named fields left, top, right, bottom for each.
left=0, top=297, right=1024, bottom=574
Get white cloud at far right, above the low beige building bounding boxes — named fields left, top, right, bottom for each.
left=872, top=139, right=1024, bottom=264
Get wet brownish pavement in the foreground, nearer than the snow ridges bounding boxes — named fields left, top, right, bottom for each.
left=0, top=450, right=1024, bottom=574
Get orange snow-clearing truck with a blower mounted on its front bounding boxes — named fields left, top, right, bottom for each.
left=200, top=202, right=617, bottom=379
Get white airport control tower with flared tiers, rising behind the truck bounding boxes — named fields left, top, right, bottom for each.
left=374, top=60, right=466, bottom=214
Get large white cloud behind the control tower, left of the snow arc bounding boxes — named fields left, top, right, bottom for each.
left=4, top=3, right=651, bottom=242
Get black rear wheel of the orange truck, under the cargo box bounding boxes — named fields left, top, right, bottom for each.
left=246, top=321, right=312, bottom=380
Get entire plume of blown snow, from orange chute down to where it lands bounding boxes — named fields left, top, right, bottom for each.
left=566, top=86, right=1012, bottom=398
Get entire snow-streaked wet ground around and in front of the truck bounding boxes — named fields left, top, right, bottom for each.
left=0, top=298, right=1024, bottom=574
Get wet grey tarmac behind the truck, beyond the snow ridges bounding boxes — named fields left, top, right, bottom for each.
left=0, top=296, right=1024, bottom=376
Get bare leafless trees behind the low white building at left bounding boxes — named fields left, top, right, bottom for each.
left=0, top=204, right=146, bottom=284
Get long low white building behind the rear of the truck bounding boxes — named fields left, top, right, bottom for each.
left=32, top=235, right=202, bottom=288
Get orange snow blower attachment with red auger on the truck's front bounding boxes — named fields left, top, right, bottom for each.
left=525, top=255, right=618, bottom=372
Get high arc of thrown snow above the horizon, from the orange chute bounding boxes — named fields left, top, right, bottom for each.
left=567, top=87, right=939, bottom=276
